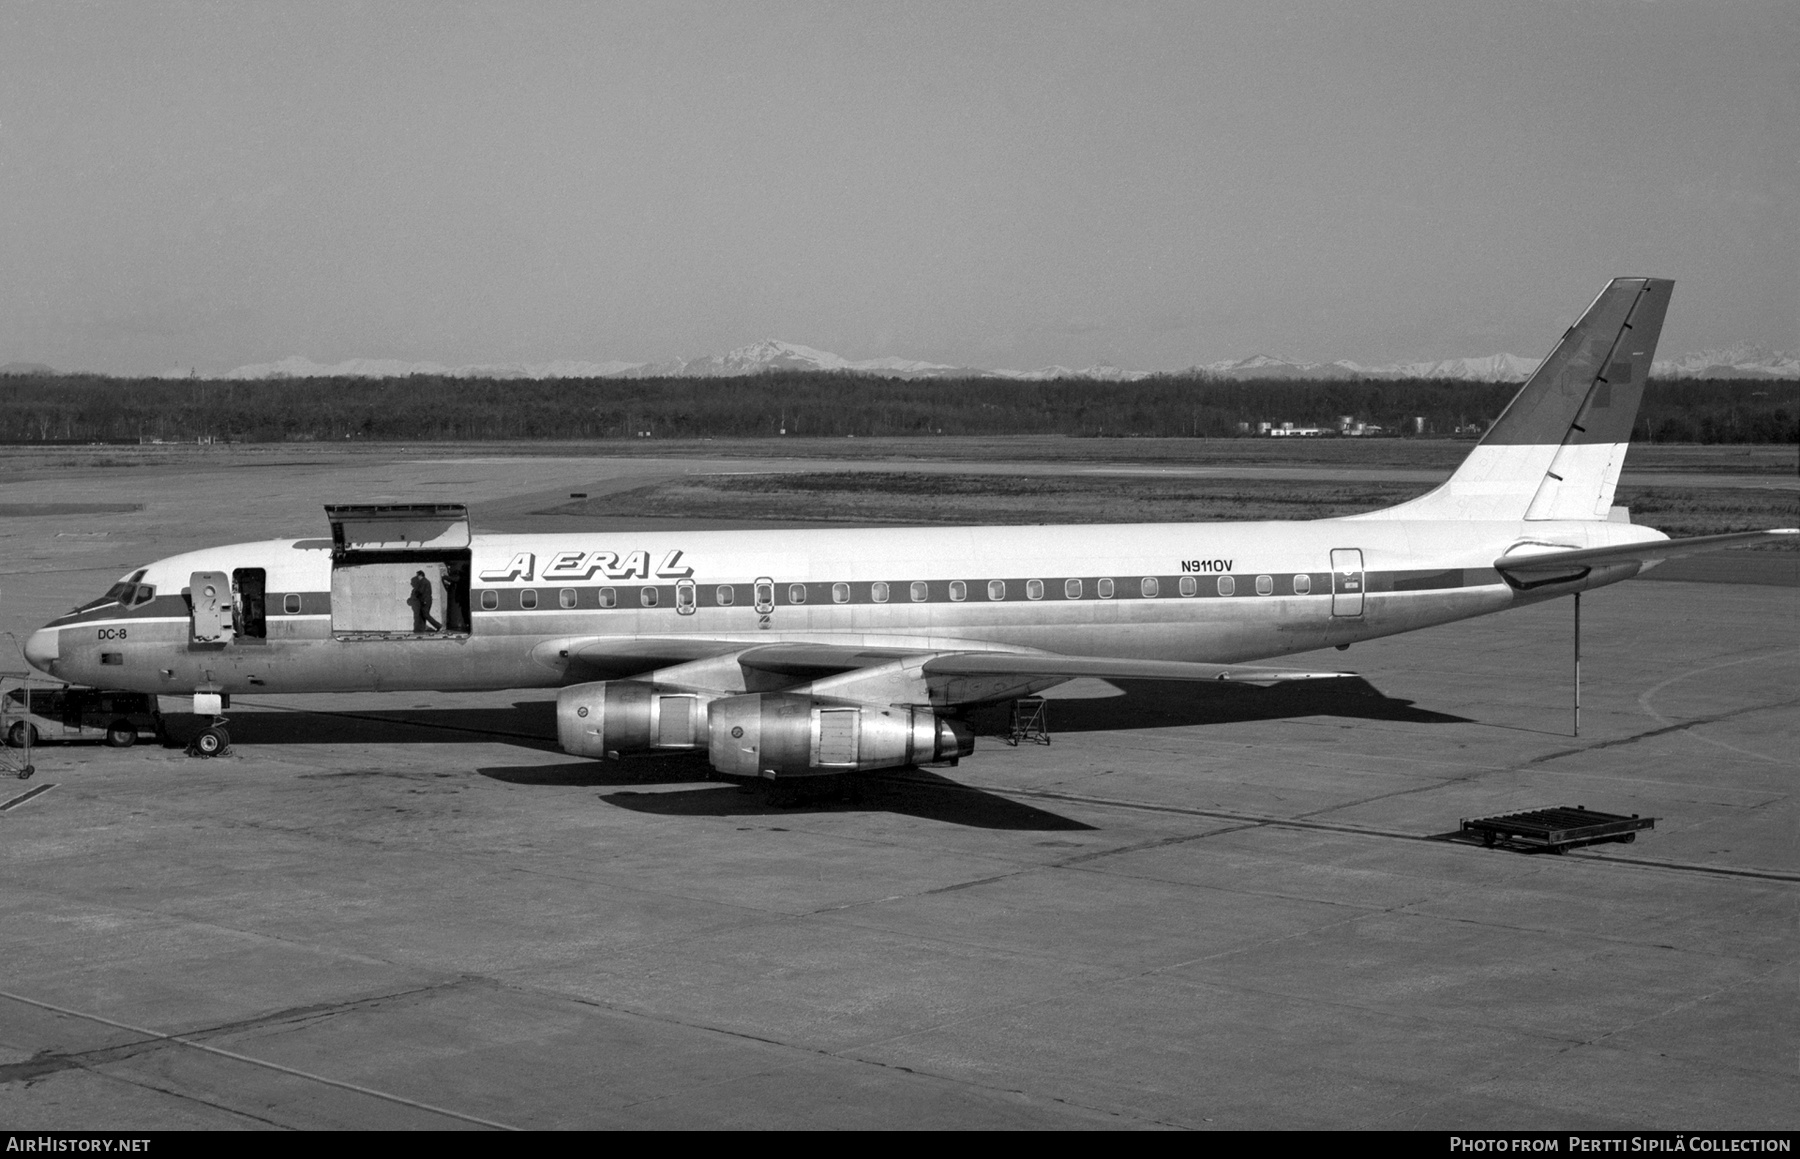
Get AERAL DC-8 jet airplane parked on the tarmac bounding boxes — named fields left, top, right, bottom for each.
left=25, top=277, right=1800, bottom=786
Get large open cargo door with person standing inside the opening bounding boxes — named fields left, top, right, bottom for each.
left=326, top=504, right=470, bottom=637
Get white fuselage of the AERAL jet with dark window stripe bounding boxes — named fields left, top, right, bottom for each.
left=29, top=518, right=1665, bottom=695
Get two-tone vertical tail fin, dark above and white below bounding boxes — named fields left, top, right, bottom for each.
left=1357, top=277, right=1674, bottom=520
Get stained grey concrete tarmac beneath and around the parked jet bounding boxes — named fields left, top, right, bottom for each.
left=0, top=448, right=1800, bottom=1130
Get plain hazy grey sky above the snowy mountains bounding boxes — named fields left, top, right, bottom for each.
left=0, top=0, right=1800, bottom=373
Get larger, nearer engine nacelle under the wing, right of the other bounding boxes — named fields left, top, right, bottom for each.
left=707, top=693, right=976, bottom=777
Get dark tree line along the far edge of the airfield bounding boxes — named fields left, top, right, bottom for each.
left=0, top=371, right=1800, bottom=443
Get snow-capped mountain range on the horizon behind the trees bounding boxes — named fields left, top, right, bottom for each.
left=14, top=338, right=1800, bottom=382
